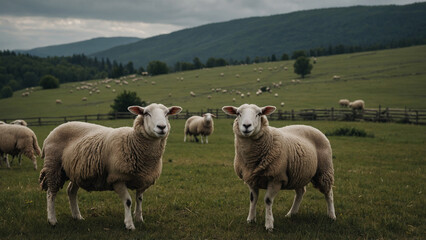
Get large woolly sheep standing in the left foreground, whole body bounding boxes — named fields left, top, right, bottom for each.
left=39, top=103, right=182, bottom=230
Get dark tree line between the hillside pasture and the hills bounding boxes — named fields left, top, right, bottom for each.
left=0, top=36, right=426, bottom=98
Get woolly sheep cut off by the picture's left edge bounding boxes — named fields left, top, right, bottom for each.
left=0, top=124, right=40, bottom=170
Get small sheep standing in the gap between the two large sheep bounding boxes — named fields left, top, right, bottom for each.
left=183, top=113, right=216, bottom=143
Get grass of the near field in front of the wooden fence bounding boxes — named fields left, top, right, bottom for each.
left=0, top=119, right=426, bottom=239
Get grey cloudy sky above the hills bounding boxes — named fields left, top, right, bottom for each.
left=0, top=0, right=422, bottom=50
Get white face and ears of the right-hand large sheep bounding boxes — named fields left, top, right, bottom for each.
left=222, top=104, right=276, bottom=137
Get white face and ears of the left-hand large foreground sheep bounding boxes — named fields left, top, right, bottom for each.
left=128, top=103, right=182, bottom=138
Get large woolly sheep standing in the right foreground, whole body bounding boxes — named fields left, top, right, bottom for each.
left=222, top=104, right=336, bottom=231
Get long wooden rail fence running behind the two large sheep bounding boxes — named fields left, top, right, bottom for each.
left=0, top=106, right=426, bottom=126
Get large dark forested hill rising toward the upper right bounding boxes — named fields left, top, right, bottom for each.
left=92, top=2, right=426, bottom=67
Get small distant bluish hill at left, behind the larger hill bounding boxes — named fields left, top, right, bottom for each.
left=16, top=37, right=141, bottom=57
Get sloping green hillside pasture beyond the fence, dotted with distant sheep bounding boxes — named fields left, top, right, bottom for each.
left=0, top=45, right=426, bottom=120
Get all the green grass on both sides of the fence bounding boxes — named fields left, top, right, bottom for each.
left=0, top=46, right=426, bottom=239
